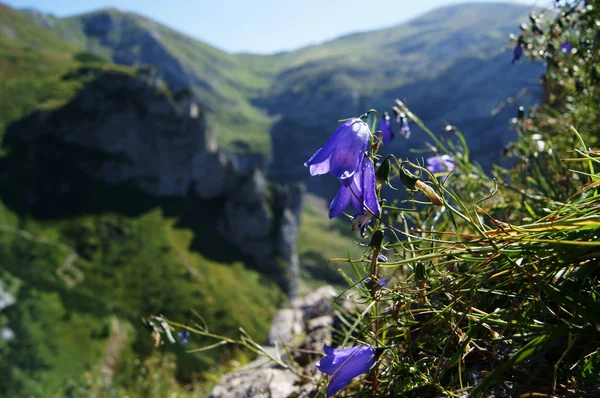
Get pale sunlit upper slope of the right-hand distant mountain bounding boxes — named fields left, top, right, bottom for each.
left=252, top=3, right=530, bottom=95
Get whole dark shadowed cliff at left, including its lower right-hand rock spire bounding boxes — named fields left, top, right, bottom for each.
left=4, top=70, right=302, bottom=296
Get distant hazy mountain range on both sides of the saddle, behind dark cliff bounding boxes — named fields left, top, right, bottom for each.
left=17, top=3, right=543, bottom=179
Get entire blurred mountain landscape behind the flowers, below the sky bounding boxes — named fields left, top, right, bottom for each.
left=0, top=3, right=542, bottom=396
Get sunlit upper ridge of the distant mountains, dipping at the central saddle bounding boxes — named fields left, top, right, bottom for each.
left=15, top=2, right=544, bottom=167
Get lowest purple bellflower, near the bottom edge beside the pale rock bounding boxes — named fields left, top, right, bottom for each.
left=317, top=345, right=381, bottom=397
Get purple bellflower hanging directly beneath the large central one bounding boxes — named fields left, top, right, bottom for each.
left=329, top=155, right=381, bottom=236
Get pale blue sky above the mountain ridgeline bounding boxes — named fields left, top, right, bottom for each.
left=0, top=0, right=548, bottom=54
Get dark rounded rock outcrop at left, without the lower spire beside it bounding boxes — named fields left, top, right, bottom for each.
left=6, top=72, right=223, bottom=199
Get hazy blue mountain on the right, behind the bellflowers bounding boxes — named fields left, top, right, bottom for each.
left=255, top=3, right=543, bottom=190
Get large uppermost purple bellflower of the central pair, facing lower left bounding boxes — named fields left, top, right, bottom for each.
left=304, top=118, right=371, bottom=179
